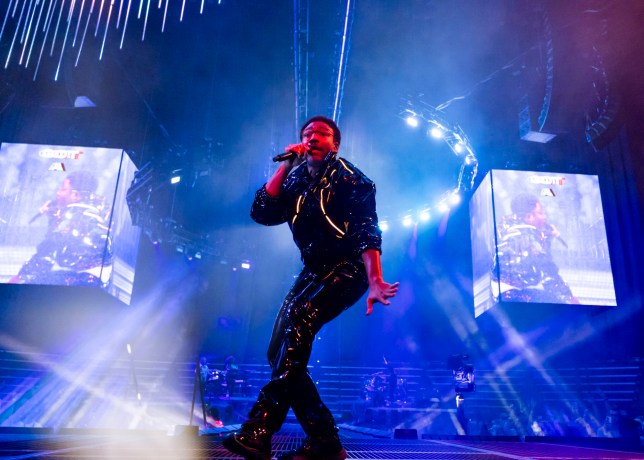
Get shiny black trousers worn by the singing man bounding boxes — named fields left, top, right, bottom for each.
left=246, top=262, right=368, bottom=442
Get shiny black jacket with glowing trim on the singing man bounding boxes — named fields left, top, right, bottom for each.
left=250, top=154, right=382, bottom=274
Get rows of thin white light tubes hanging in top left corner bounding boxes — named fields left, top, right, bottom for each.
left=0, top=0, right=221, bottom=81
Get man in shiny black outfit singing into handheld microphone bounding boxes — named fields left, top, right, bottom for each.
left=224, top=116, right=398, bottom=460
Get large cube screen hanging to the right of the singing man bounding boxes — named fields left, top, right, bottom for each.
left=470, top=170, right=617, bottom=316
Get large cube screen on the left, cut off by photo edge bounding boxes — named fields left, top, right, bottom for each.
left=0, top=143, right=140, bottom=304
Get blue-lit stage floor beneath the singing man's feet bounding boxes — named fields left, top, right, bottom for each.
left=0, top=426, right=644, bottom=460
